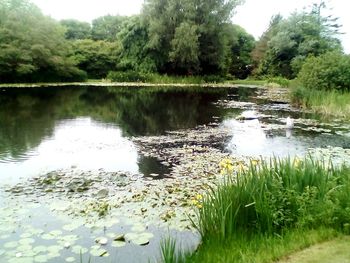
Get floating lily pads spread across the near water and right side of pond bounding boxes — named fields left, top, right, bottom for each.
left=0, top=87, right=350, bottom=263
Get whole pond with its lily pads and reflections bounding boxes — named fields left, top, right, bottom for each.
left=0, top=87, right=350, bottom=262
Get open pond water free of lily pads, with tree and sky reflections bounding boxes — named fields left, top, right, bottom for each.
left=0, top=87, right=350, bottom=183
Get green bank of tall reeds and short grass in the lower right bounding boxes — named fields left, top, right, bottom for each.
left=163, top=159, right=350, bottom=262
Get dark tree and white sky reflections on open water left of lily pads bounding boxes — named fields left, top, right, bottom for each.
left=0, top=87, right=228, bottom=184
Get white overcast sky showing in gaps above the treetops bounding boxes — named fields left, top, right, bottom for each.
left=32, top=0, right=350, bottom=53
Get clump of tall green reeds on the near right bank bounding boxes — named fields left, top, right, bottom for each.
left=197, top=158, right=350, bottom=240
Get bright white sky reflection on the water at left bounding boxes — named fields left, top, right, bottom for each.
left=0, top=118, right=138, bottom=185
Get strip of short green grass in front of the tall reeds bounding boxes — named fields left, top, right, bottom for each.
left=187, top=228, right=341, bottom=263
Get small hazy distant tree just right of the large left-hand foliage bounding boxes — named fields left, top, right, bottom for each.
left=60, top=19, right=91, bottom=39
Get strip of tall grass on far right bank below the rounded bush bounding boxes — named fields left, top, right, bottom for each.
left=291, top=87, right=350, bottom=120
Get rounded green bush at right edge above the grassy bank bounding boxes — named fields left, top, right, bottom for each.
left=298, top=52, right=350, bottom=91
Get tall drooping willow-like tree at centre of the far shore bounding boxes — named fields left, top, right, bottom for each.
left=143, top=0, right=241, bottom=74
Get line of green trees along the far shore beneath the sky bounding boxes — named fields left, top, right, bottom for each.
left=0, top=0, right=342, bottom=82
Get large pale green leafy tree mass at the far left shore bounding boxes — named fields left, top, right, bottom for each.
left=0, top=0, right=85, bottom=82
